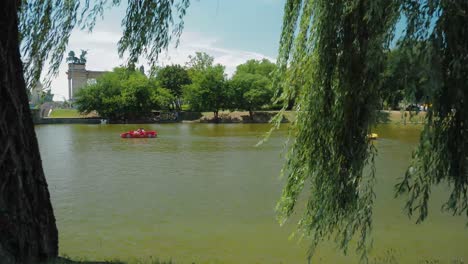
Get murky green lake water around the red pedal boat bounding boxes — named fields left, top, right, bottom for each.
left=36, top=124, right=468, bottom=263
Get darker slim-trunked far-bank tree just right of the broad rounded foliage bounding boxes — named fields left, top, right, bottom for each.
left=155, top=64, right=191, bottom=110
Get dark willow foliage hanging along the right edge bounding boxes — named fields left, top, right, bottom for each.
left=396, top=0, right=468, bottom=225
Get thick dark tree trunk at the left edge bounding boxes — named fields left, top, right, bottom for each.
left=0, top=0, right=58, bottom=264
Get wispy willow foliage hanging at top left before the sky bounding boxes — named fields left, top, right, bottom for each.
left=18, top=0, right=190, bottom=87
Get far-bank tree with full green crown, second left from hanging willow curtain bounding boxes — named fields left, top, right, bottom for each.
left=185, top=64, right=228, bottom=122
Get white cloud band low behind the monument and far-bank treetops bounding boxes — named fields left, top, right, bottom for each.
left=51, top=30, right=274, bottom=100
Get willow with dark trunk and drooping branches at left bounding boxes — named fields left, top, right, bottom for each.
left=0, top=0, right=189, bottom=263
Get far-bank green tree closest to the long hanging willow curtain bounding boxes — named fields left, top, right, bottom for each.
left=229, top=59, right=275, bottom=119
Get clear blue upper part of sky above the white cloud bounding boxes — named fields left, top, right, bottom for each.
left=185, top=0, right=285, bottom=57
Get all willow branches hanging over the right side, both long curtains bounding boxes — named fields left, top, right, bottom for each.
left=276, top=0, right=468, bottom=257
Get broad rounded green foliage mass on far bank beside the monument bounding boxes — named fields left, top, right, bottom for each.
left=76, top=68, right=173, bottom=119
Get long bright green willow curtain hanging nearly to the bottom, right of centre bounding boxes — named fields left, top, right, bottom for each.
left=275, top=0, right=398, bottom=257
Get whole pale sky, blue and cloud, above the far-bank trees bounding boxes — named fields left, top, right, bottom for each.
left=51, top=0, right=285, bottom=101
